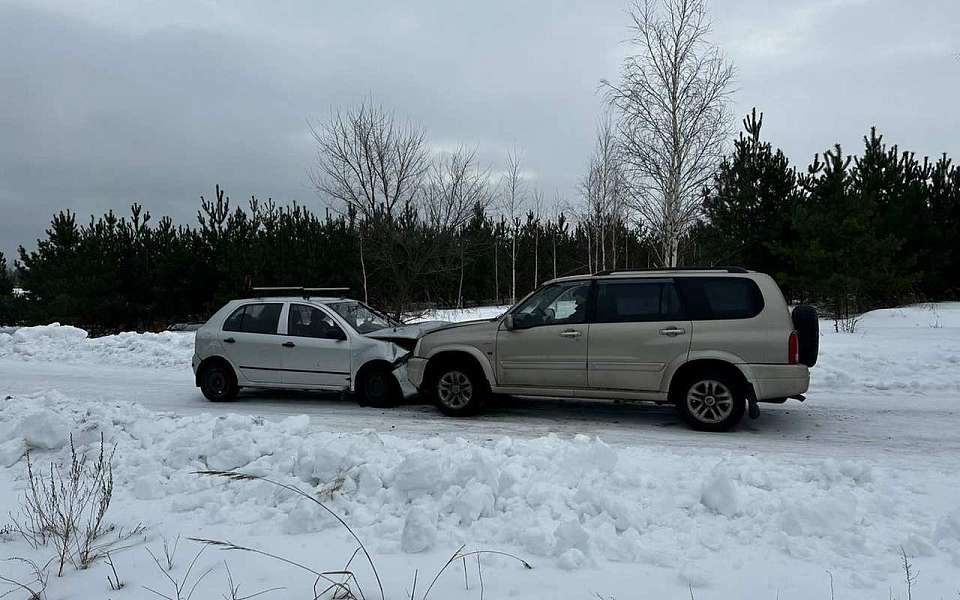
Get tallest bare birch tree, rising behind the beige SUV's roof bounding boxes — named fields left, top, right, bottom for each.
left=603, top=0, right=734, bottom=267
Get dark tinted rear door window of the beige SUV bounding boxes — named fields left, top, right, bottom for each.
left=594, top=281, right=682, bottom=323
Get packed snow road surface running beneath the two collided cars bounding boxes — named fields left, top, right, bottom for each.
left=0, top=359, right=960, bottom=462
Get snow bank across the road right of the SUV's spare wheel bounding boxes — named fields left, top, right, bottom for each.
left=810, top=302, right=960, bottom=395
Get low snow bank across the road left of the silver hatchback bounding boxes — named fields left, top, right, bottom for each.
left=0, top=323, right=194, bottom=368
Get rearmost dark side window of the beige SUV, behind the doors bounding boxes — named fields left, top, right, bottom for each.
left=677, top=277, right=763, bottom=321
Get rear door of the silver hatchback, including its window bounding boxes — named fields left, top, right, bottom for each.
left=220, top=302, right=283, bottom=383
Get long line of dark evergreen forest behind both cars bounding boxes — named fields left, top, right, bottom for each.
left=0, top=110, right=960, bottom=333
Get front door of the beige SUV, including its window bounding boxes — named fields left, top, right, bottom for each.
left=496, top=281, right=591, bottom=395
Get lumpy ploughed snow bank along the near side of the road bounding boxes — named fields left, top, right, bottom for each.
left=0, top=392, right=960, bottom=579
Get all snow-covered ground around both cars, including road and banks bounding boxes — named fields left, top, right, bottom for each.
left=0, top=304, right=960, bottom=600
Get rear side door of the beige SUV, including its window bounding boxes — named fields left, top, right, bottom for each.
left=587, top=279, right=692, bottom=392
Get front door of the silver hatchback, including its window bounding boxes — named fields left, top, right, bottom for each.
left=283, top=303, right=350, bottom=389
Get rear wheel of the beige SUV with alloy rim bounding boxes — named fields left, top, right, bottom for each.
left=675, top=369, right=747, bottom=431
